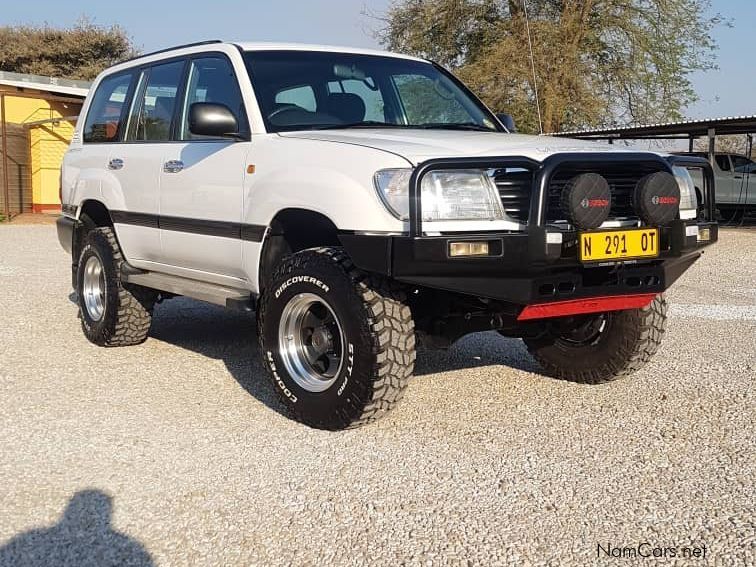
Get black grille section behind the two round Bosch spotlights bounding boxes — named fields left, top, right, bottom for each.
left=546, top=164, right=662, bottom=222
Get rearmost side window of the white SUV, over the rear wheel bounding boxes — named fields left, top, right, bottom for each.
left=84, top=73, right=134, bottom=143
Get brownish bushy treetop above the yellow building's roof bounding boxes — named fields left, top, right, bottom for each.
left=0, top=20, right=137, bottom=80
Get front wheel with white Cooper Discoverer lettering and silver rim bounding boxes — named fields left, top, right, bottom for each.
left=257, top=247, right=415, bottom=430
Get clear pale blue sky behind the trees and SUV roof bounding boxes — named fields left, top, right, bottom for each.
left=0, top=0, right=756, bottom=118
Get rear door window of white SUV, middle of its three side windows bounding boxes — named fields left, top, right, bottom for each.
left=126, top=61, right=184, bottom=142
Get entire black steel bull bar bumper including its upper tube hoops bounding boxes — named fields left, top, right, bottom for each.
left=340, top=152, right=718, bottom=306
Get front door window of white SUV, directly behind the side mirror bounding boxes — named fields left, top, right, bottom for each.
left=179, top=57, right=249, bottom=140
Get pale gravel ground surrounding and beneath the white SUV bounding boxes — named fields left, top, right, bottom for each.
left=0, top=225, right=756, bottom=566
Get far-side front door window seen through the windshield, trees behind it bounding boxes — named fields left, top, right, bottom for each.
left=394, top=75, right=471, bottom=124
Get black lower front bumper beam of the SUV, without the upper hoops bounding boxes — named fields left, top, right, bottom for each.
left=340, top=221, right=718, bottom=305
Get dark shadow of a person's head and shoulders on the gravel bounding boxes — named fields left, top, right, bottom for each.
left=0, top=490, right=154, bottom=567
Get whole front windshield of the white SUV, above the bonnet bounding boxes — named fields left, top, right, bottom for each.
left=245, top=51, right=501, bottom=132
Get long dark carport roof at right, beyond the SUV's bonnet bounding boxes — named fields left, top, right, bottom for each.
left=551, top=115, right=756, bottom=140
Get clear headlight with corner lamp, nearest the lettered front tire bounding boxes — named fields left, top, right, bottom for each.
left=375, top=169, right=504, bottom=221
